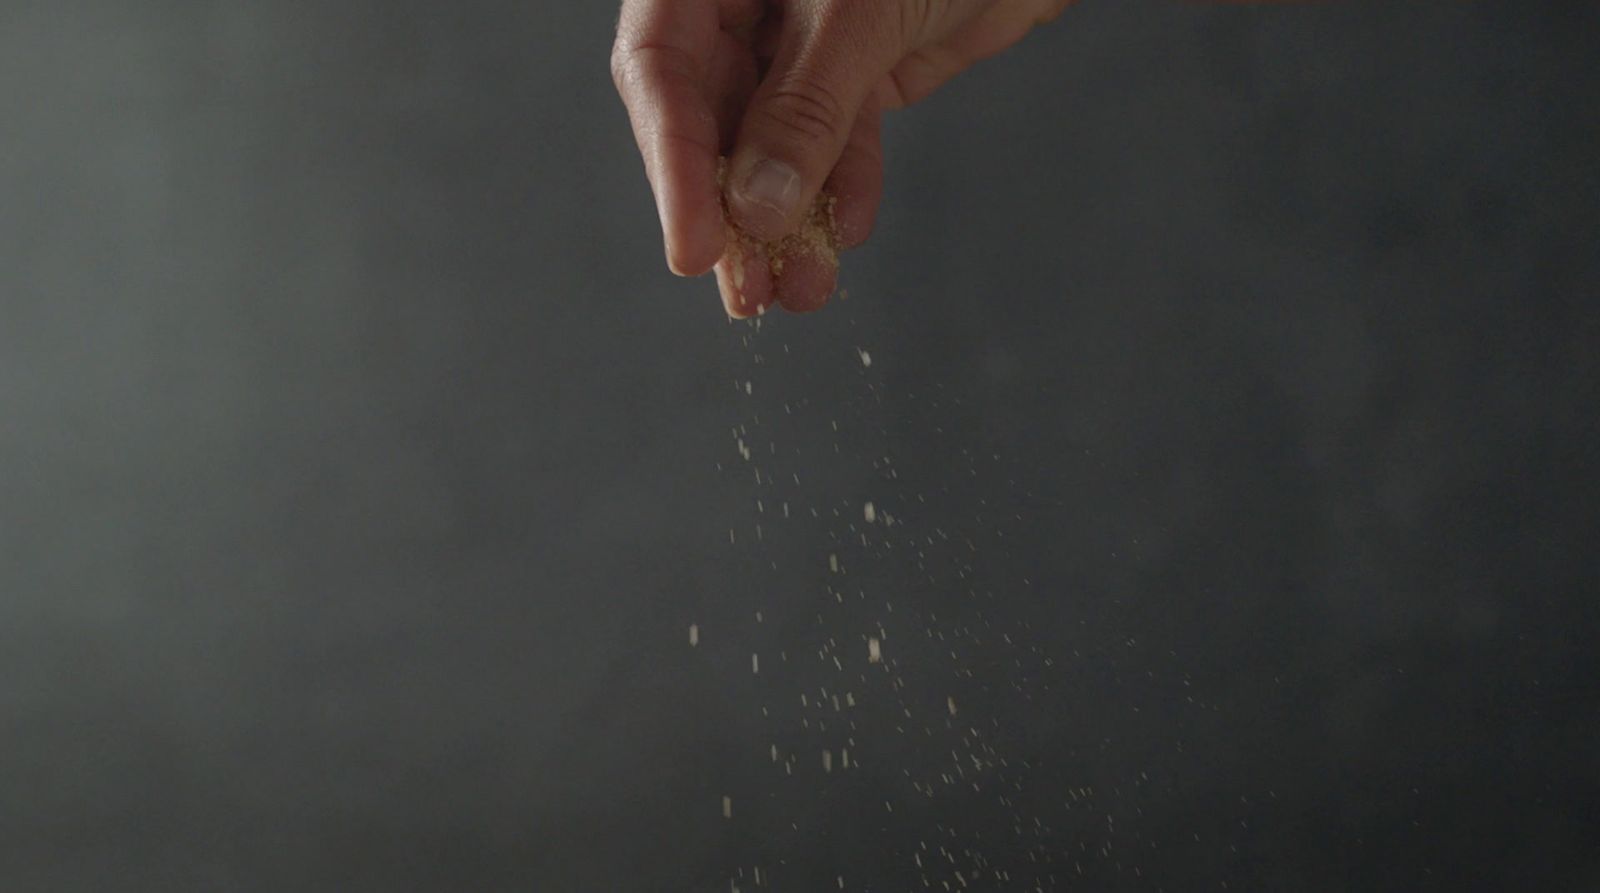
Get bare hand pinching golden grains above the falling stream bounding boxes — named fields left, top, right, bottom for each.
left=611, top=0, right=1070, bottom=317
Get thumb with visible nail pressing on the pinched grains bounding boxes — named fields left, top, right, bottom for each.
left=728, top=0, right=904, bottom=240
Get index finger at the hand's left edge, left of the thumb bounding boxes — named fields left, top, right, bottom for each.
left=611, top=0, right=760, bottom=275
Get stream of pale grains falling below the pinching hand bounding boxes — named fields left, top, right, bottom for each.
left=688, top=304, right=1177, bottom=893
